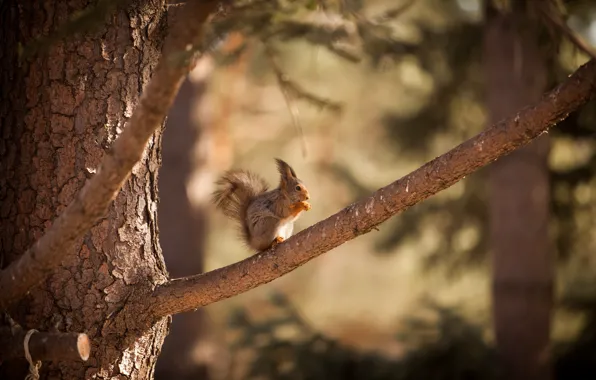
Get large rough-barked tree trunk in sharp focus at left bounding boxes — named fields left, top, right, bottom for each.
left=0, top=0, right=168, bottom=379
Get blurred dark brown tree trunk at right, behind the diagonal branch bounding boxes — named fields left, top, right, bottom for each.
left=485, top=2, right=553, bottom=380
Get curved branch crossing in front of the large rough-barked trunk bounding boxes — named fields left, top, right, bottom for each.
left=0, top=0, right=219, bottom=309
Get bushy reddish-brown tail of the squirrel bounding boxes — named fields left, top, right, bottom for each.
left=213, top=170, right=268, bottom=235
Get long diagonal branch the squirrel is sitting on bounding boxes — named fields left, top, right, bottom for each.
left=147, top=60, right=596, bottom=321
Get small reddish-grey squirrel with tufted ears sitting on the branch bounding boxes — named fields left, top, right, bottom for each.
left=212, top=158, right=311, bottom=252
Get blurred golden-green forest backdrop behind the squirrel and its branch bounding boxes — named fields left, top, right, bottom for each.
left=156, top=0, right=596, bottom=379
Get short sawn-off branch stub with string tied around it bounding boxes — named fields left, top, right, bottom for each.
left=0, top=327, right=91, bottom=361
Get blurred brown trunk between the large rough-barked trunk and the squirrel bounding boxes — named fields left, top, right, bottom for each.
left=156, top=64, right=210, bottom=380
